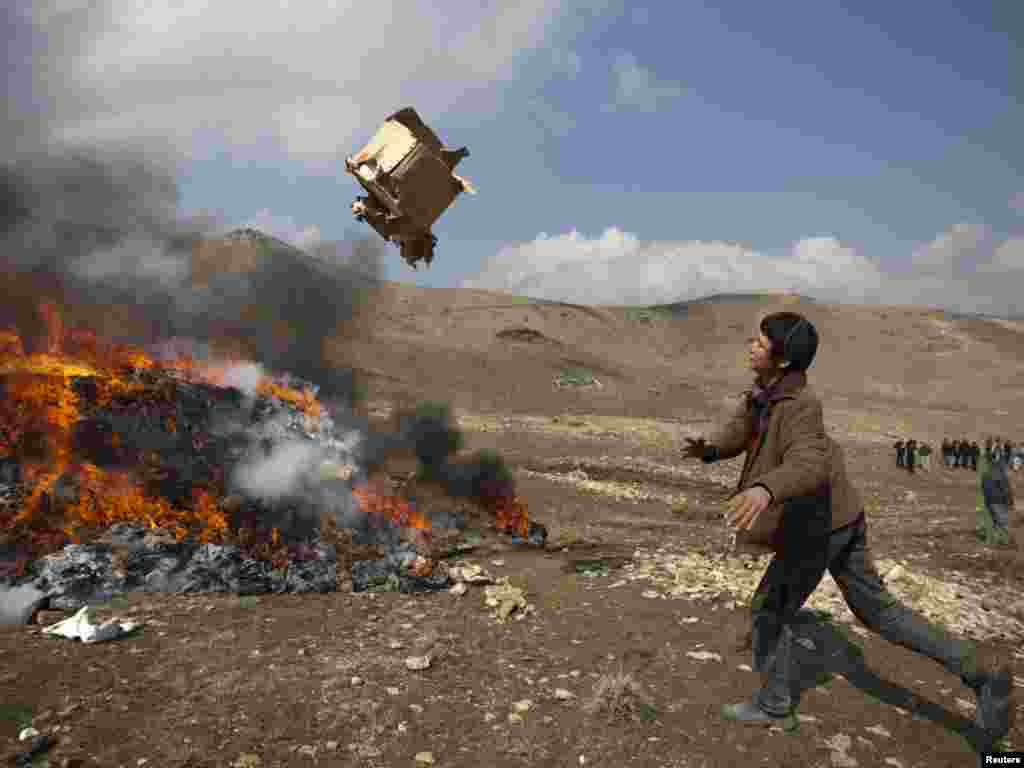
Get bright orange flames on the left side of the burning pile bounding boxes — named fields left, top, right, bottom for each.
left=0, top=302, right=323, bottom=558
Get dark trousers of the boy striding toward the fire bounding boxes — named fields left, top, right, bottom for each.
left=751, top=509, right=981, bottom=715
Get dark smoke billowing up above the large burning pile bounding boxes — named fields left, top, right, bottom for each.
left=0, top=3, right=384, bottom=396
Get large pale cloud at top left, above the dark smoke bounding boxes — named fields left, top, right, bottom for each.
left=33, top=0, right=572, bottom=166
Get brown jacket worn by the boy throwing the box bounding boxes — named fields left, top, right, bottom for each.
left=710, top=371, right=864, bottom=544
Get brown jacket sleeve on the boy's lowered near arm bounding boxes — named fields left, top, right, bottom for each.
left=754, top=399, right=831, bottom=502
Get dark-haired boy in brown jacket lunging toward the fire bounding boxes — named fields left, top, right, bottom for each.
left=683, top=312, right=1014, bottom=739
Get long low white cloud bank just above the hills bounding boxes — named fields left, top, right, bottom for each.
left=462, top=226, right=1024, bottom=311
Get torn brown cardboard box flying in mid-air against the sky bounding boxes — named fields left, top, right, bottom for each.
left=345, top=106, right=476, bottom=268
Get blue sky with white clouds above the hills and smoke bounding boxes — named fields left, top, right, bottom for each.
left=9, top=0, right=1024, bottom=312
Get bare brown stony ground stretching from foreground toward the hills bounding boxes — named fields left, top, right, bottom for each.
left=6, top=294, right=1024, bottom=768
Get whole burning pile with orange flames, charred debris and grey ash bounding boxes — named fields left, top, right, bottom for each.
left=0, top=304, right=546, bottom=608
